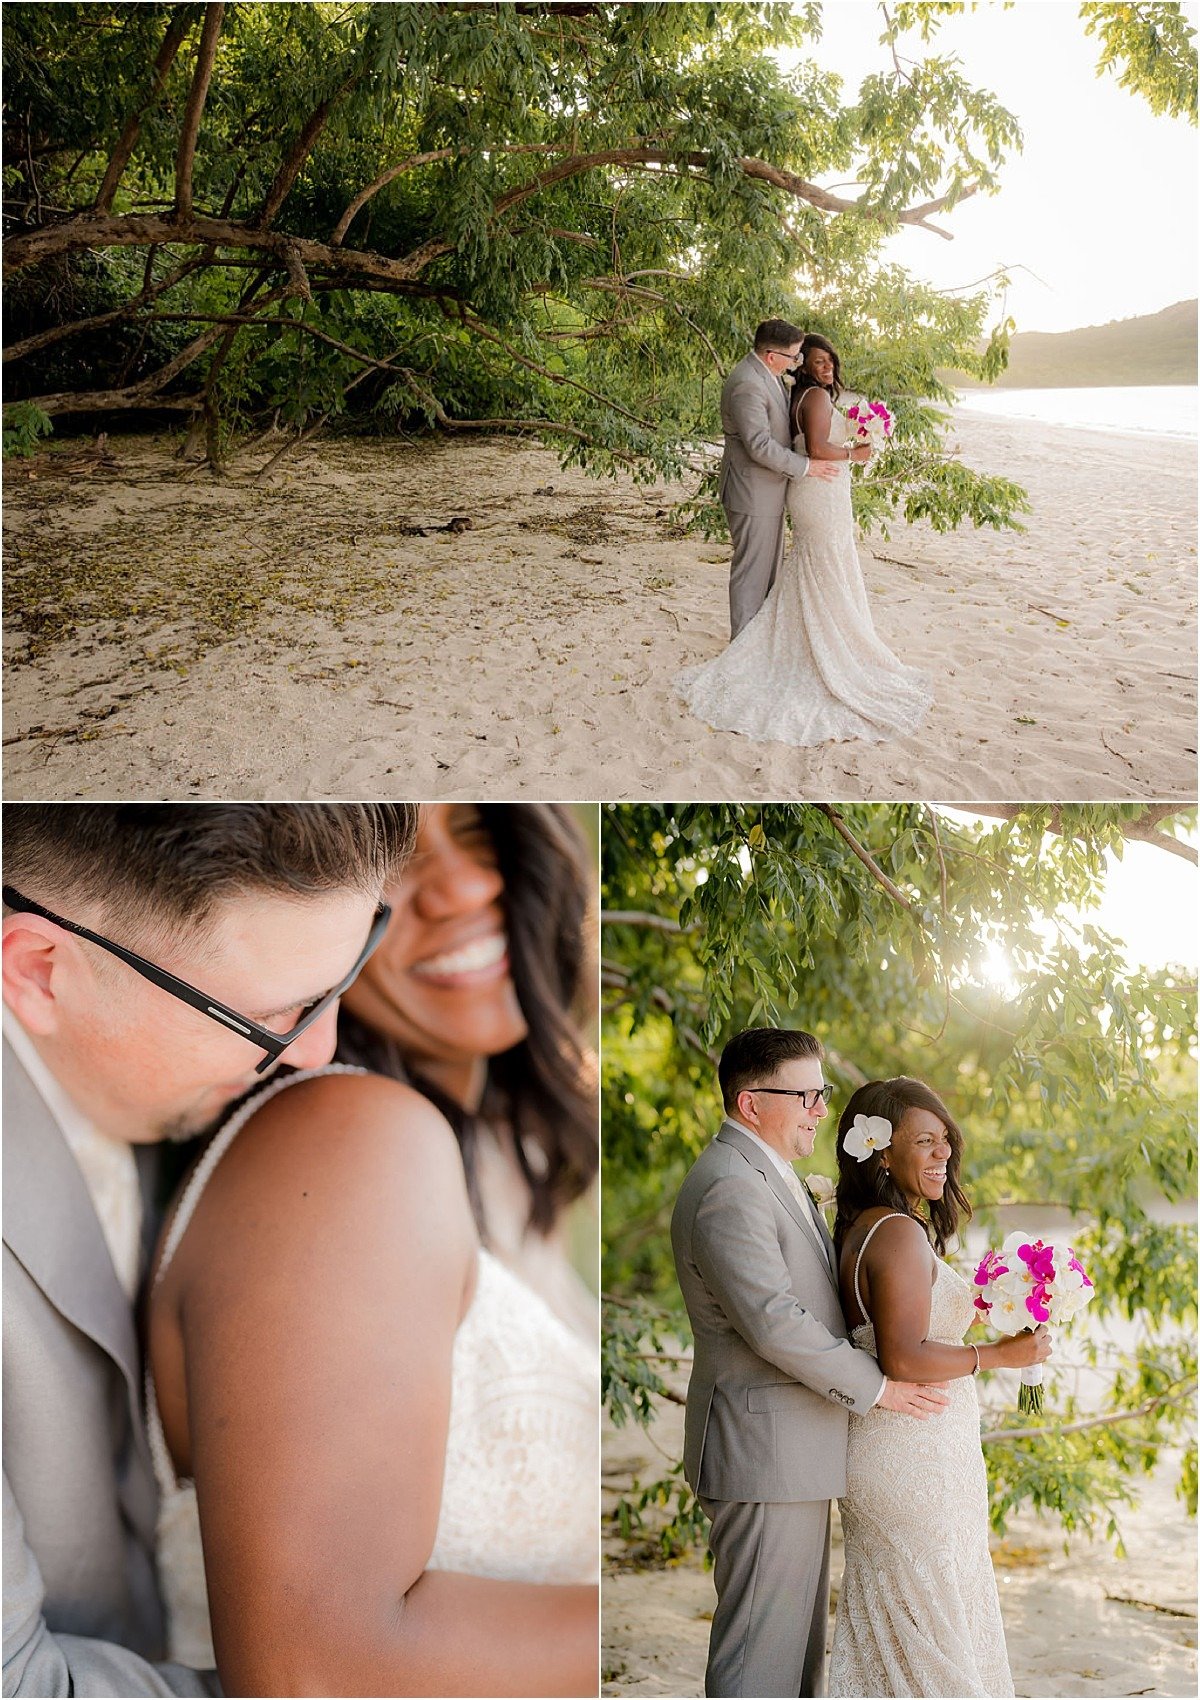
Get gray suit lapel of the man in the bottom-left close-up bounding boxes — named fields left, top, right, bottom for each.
left=3, top=1046, right=155, bottom=1532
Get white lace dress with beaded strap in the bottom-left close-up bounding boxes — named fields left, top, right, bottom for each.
left=146, top=1063, right=600, bottom=1669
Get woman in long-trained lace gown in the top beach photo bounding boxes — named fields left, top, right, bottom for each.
left=678, top=337, right=931, bottom=745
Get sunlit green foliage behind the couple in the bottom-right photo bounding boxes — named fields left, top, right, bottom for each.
left=602, top=802, right=1197, bottom=1545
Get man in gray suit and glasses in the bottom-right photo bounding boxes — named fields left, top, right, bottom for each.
left=671, top=1027, right=947, bottom=1697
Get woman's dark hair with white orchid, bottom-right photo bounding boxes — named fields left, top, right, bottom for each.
left=833, top=1074, right=972, bottom=1256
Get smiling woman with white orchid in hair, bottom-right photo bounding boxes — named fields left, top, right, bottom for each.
left=829, top=1076, right=1050, bottom=1697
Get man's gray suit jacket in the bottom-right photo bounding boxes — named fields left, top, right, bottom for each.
left=671, top=1122, right=884, bottom=1501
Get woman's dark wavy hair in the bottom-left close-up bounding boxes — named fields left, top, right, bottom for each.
left=338, top=802, right=600, bottom=1236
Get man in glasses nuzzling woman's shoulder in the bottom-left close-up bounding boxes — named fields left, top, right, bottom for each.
left=3, top=802, right=415, bottom=1695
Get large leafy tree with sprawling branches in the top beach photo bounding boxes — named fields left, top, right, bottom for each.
left=5, top=0, right=1121, bottom=527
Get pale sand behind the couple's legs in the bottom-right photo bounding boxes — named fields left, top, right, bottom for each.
left=600, top=1408, right=1197, bottom=1697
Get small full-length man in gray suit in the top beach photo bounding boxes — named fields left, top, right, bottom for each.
left=717, top=320, right=840, bottom=641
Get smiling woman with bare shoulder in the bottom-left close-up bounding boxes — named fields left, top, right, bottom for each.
left=148, top=806, right=598, bottom=1695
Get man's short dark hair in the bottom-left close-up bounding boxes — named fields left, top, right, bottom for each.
left=3, top=802, right=416, bottom=933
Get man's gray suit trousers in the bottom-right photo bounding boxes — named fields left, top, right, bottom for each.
left=700, top=1499, right=829, bottom=1697
